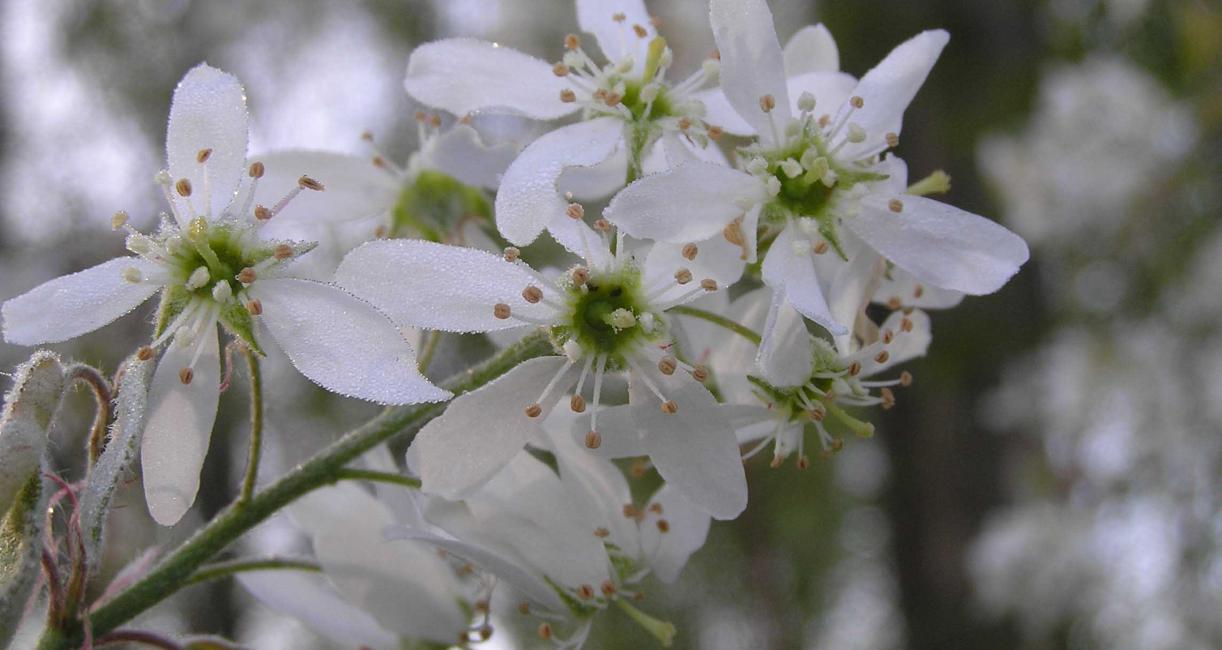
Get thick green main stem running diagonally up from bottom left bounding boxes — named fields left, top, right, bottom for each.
left=38, top=330, right=555, bottom=650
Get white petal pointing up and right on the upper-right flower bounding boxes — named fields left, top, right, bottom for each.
left=840, top=29, right=951, bottom=160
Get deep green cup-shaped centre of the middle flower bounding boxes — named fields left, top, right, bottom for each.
left=551, top=265, right=664, bottom=369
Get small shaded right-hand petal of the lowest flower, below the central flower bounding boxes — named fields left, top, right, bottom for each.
left=640, top=485, right=712, bottom=583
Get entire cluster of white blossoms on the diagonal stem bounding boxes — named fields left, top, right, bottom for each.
left=4, top=0, right=1028, bottom=648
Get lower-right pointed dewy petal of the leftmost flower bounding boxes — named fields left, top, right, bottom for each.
left=251, top=279, right=450, bottom=404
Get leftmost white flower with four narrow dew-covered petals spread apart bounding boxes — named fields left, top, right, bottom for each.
left=2, top=65, right=448, bottom=525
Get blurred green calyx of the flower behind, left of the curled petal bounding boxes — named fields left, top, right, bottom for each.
left=390, top=170, right=491, bottom=243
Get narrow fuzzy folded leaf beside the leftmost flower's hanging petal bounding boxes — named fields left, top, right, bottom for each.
left=81, top=354, right=156, bottom=569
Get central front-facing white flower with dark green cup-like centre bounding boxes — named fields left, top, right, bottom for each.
left=336, top=233, right=747, bottom=519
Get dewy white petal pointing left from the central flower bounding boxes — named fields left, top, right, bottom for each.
left=335, top=239, right=555, bottom=332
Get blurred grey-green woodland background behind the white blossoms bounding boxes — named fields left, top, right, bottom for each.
left=0, top=0, right=1222, bottom=650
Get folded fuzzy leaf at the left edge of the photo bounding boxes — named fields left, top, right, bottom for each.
left=0, top=351, right=65, bottom=645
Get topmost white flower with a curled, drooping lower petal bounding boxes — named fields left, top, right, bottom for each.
left=406, top=0, right=720, bottom=253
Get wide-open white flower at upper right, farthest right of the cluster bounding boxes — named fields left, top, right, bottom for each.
left=605, top=0, right=1028, bottom=335
